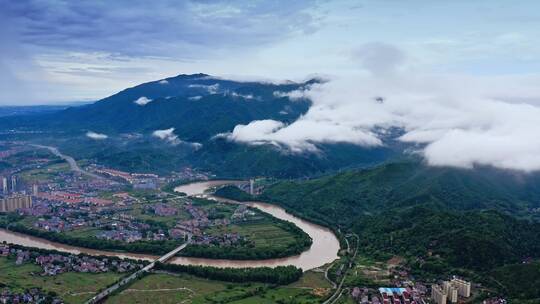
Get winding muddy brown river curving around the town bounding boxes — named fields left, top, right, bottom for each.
left=0, top=180, right=339, bottom=271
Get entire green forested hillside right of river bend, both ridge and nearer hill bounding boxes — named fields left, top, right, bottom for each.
left=261, top=161, right=540, bottom=273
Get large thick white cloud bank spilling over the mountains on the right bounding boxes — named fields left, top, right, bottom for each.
left=226, top=71, right=540, bottom=171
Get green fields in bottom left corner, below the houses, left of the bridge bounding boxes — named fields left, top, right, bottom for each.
left=0, top=258, right=122, bottom=303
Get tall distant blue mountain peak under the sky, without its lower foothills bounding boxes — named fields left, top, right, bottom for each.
left=0, top=74, right=317, bottom=141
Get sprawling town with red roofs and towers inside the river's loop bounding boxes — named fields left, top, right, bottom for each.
left=0, top=142, right=278, bottom=254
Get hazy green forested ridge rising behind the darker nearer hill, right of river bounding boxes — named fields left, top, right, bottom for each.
left=263, top=160, right=540, bottom=226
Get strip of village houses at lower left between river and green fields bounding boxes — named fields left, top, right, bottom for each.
left=0, top=244, right=143, bottom=276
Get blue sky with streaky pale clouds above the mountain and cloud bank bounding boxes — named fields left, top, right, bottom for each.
left=0, top=0, right=540, bottom=104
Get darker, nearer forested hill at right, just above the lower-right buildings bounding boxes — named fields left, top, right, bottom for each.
left=352, top=206, right=540, bottom=272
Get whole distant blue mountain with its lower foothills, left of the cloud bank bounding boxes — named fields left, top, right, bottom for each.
left=0, top=74, right=400, bottom=177
